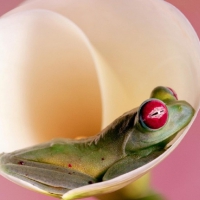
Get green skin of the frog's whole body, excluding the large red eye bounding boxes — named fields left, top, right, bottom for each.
left=0, top=86, right=194, bottom=196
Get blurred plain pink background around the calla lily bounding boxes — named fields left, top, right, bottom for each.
left=0, top=0, right=200, bottom=200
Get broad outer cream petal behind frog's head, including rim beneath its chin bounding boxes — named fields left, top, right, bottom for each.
left=2, top=0, right=200, bottom=199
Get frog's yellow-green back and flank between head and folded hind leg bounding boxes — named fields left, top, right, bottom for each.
left=19, top=110, right=133, bottom=179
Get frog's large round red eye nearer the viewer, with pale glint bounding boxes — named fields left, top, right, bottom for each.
left=139, top=99, right=168, bottom=129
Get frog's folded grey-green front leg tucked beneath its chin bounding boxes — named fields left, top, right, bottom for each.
left=103, top=150, right=164, bottom=181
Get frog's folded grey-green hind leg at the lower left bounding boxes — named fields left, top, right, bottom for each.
left=0, top=154, right=97, bottom=196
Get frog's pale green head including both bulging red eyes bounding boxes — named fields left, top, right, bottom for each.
left=126, top=86, right=195, bottom=151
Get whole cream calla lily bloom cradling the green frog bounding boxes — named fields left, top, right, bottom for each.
left=0, top=0, right=200, bottom=200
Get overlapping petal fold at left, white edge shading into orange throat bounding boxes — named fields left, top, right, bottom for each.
left=0, top=10, right=101, bottom=152
